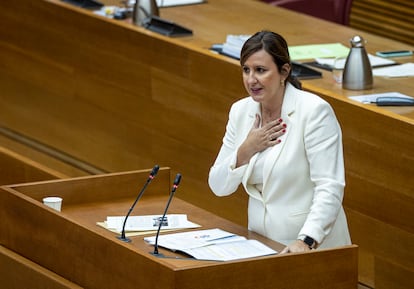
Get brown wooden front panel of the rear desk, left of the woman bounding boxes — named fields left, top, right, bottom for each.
left=0, top=1, right=246, bottom=224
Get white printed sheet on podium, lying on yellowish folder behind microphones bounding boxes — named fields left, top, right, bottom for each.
left=106, top=214, right=200, bottom=232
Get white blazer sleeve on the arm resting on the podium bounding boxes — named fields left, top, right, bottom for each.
left=299, top=101, right=345, bottom=243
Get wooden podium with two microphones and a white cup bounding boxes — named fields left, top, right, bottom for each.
left=0, top=168, right=358, bottom=289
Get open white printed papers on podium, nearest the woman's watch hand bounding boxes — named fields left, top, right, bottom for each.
left=144, top=229, right=277, bottom=261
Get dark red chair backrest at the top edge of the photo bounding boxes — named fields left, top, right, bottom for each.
left=262, top=0, right=352, bottom=25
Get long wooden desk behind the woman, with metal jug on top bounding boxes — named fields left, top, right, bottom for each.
left=0, top=0, right=414, bottom=288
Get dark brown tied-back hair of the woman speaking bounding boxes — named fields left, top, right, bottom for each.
left=240, top=30, right=302, bottom=89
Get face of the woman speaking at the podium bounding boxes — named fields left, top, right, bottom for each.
left=242, top=49, right=287, bottom=104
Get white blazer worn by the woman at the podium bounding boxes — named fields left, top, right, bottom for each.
left=208, top=84, right=351, bottom=248
